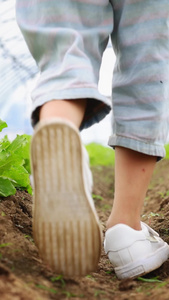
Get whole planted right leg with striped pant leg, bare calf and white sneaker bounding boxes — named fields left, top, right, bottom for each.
left=105, top=0, right=169, bottom=278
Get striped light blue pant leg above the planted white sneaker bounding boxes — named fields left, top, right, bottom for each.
left=109, top=0, right=169, bottom=158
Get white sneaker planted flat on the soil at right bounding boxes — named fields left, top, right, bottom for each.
left=104, top=222, right=169, bottom=279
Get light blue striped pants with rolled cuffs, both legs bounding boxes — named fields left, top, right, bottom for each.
left=16, top=0, right=169, bottom=157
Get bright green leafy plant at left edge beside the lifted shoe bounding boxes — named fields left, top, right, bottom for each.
left=0, top=120, right=32, bottom=197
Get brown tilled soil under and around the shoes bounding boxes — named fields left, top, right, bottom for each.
left=0, top=160, right=169, bottom=300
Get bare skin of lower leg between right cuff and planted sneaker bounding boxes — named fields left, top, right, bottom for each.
left=107, top=147, right=156, bottom=230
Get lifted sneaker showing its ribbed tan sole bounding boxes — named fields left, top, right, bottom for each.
left=31, top=119, right=101, bottom=276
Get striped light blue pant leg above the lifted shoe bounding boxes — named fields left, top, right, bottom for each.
left=16, top=0, right=113, bottom=128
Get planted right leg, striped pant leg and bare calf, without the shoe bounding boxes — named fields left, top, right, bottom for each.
left=108, top=0, right=169, bottom=229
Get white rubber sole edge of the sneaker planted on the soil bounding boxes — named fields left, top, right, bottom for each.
left=114, top=243, right=169, bottom=279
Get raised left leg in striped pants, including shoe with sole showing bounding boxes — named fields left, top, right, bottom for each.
left=17, top=0, right=113, bottom=276
